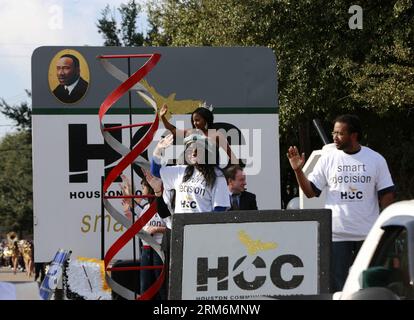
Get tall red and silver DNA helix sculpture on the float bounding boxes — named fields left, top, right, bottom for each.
left=97, top=53, right=165, bottom=300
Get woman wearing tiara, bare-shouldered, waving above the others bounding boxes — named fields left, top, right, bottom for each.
left=160, top=103, right=239, bottom=168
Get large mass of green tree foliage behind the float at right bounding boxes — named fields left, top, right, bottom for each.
left=100, top=0, right=414, bottom=198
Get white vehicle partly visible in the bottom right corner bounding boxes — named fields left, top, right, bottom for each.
left=333, top=200, right=414, bottom=300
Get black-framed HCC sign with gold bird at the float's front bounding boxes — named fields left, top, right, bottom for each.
left=169, top=209, right=331, bottom=300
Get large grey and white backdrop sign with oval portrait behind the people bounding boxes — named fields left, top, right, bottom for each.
left=32, top=47, right=280, bottom=261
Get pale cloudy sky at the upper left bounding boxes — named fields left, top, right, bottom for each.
left=0, top=0, right=147, bottom=139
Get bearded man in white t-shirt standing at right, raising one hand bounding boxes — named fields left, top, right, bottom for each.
left=287, top=115, right=394, bottom=292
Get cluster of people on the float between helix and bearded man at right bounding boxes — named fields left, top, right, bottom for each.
left=121, top=105, right=257, bottom=299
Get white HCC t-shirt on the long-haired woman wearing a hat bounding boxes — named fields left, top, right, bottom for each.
left=160, top=165, right=230, bottom=213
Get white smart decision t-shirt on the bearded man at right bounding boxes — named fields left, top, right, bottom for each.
left=308, top=147, right=394, bottom=241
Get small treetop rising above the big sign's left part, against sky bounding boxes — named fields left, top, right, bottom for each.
left=97, top=0, right=144, bottom=47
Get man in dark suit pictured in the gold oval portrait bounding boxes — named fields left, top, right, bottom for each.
left=53, top=54, right=88, bottom=103
